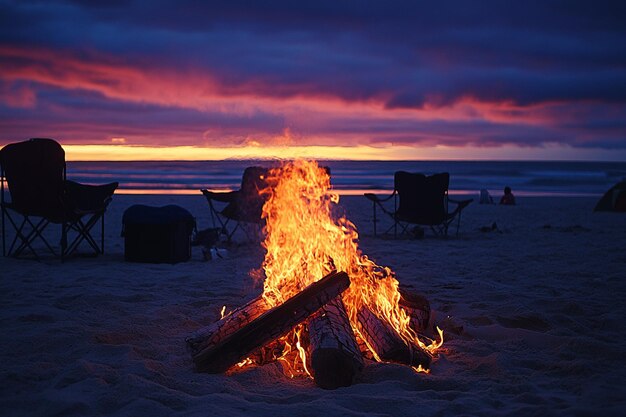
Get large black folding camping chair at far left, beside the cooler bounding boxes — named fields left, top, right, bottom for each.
left=0, top=138, right=118, bottom=260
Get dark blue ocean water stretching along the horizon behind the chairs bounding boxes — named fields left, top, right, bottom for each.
left=67, top=160, right=626, bottom=196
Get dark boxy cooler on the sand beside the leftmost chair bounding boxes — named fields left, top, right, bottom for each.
left=122, top=204, right=196, bottom=263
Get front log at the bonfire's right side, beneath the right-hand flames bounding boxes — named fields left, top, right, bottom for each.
left=357, top=305, right=432, bottom=368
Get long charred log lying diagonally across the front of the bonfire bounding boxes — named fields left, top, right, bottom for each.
left=193, top=272, right=350, bottom=373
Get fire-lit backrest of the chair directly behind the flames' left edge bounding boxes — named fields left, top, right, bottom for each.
left=230, top=166, right=269, bottom=223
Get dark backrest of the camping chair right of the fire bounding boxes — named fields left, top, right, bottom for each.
left=394, top=171, right=450, bottom=225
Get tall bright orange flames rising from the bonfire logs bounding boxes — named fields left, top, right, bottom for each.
left=261, top=160, right=443, bottom=375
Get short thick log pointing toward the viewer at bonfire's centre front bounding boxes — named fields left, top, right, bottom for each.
left=308, top=297, right=363, bottom=389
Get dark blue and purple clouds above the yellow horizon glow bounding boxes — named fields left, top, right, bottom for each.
left=0, top=0, right=626, bottom=148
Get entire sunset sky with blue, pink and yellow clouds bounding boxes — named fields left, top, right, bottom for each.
left=0, top=0, right=626, bottom=161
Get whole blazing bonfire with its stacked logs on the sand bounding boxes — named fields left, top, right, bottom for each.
left=187, top=160, right=443, bottom=388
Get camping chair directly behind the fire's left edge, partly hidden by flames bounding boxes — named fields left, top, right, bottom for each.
left=200, top=167, right=269, bottom=243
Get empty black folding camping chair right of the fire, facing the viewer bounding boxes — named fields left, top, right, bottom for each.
left=365, top=171, right=472, bottom=237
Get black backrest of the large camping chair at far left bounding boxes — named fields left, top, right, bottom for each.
left=0, top=138, right=65, bottom=219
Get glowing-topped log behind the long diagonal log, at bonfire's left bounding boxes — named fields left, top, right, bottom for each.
left=186, top=295, right=269, bottom=356
